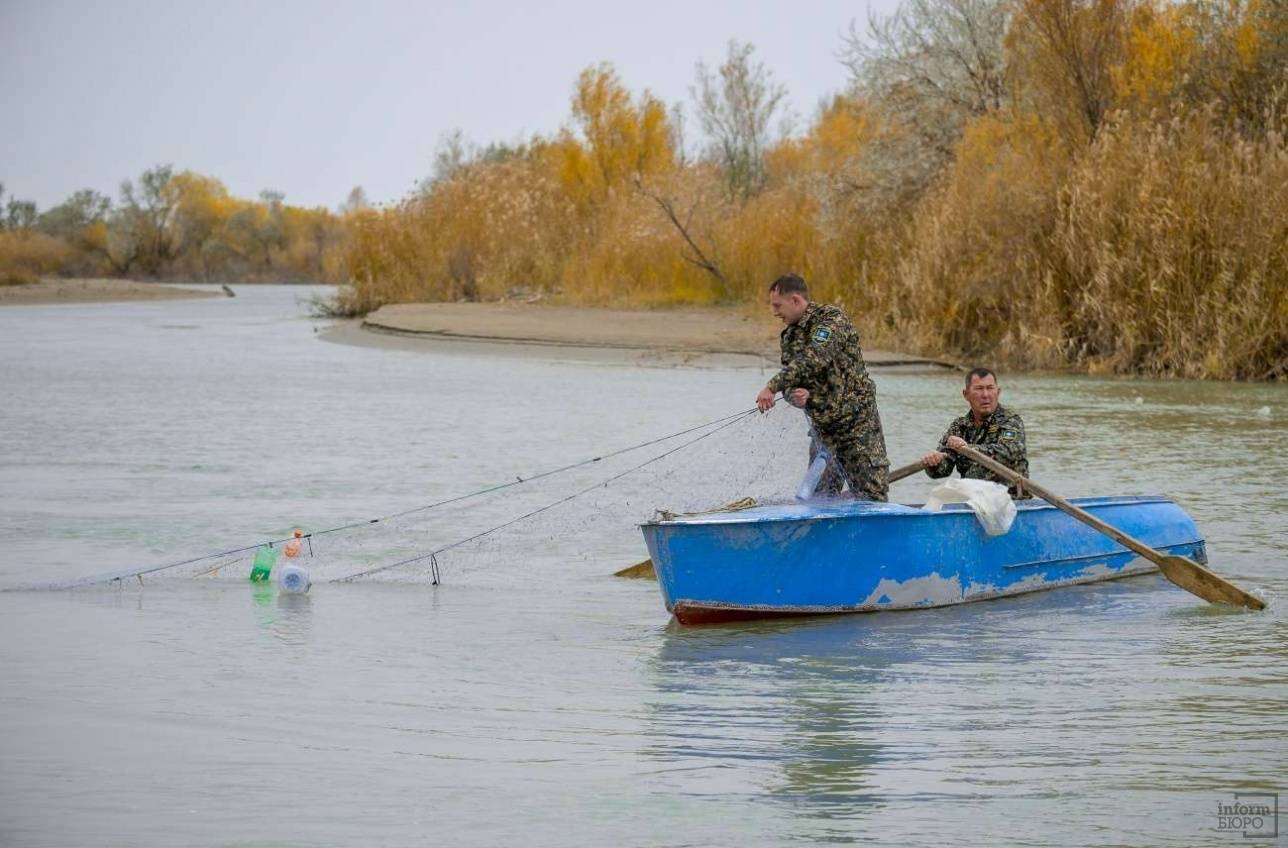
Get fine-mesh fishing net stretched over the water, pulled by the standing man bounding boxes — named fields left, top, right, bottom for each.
left=185, top=403, right=809, bottom=586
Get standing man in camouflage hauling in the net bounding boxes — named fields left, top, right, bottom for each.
left=756, top=275, right=890, bottom=500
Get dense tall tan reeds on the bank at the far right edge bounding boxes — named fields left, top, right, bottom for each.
left=1051, top=110, right=1288, bottom=380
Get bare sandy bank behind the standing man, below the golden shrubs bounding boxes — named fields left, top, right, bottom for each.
left=327, top=303, right=956, bottom=369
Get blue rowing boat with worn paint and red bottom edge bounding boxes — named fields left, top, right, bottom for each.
left=640, top=496, right=1207, bottom=624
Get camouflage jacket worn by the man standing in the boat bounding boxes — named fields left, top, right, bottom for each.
left=768, top=302, right=876, bottom=430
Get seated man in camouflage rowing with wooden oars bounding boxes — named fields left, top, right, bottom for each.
left=921, top=369, right=1032, bottom=499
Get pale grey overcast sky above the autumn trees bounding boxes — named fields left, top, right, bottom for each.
left=0, top=0, right=896, bottom=209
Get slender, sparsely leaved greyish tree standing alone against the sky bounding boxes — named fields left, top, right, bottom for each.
left=690, top=41, right=787, bottom=200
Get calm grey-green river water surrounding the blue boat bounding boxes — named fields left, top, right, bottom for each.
left=0, top=286, right=1288, bottom=845
